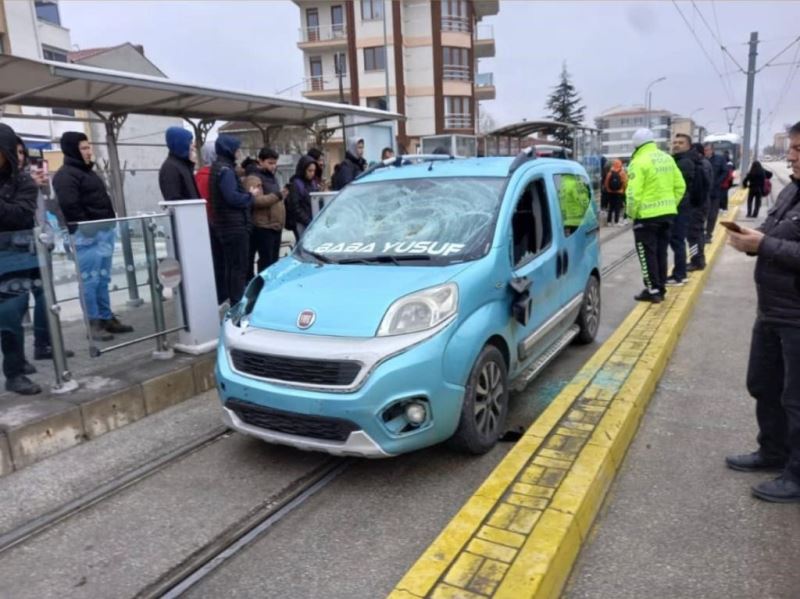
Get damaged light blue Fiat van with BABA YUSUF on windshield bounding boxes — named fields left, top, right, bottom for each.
left=216, top=154, right=600, bottom=457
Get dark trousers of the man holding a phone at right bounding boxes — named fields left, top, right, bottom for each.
left=747, top=319, right=800, bottom=482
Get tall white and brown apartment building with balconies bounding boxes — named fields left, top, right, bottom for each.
left=294, top=0, right=499, bottom=152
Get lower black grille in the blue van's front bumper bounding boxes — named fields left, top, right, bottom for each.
left=225, top=398, right=359, bottom=441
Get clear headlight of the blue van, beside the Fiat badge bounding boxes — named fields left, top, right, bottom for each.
left=378, top=283, right=458, bottom=337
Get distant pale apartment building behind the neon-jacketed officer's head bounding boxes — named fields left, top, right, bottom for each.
left=595, top=108, right=673, bottom=160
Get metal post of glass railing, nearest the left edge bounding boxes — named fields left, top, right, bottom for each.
left=33, top=227, right=78, bottom=393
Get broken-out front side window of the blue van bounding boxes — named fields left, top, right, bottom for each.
left=511, top=179, right=553, bottom=268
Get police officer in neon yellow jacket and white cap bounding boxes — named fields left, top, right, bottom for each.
left=626, top=128, right=686, bottom=304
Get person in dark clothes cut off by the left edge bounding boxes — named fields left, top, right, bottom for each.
left=0, top=123, right=41, bottom=395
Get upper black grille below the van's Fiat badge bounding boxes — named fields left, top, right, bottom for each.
left=231, top=349, right=361, bottom=386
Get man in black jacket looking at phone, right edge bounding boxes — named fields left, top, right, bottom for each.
left=726, top=122, right=800, bottom=503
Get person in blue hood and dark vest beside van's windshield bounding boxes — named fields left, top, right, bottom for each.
left=209, top=135, right=253, bottom=306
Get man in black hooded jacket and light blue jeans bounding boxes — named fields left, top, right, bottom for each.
left=53, top=131, right=133, bottom=341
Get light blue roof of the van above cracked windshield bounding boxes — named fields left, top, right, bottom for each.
left=353, top=156, right=580, bottom=184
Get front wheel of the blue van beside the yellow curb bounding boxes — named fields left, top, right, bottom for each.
left=450, top=345, right=508, bottom=455
